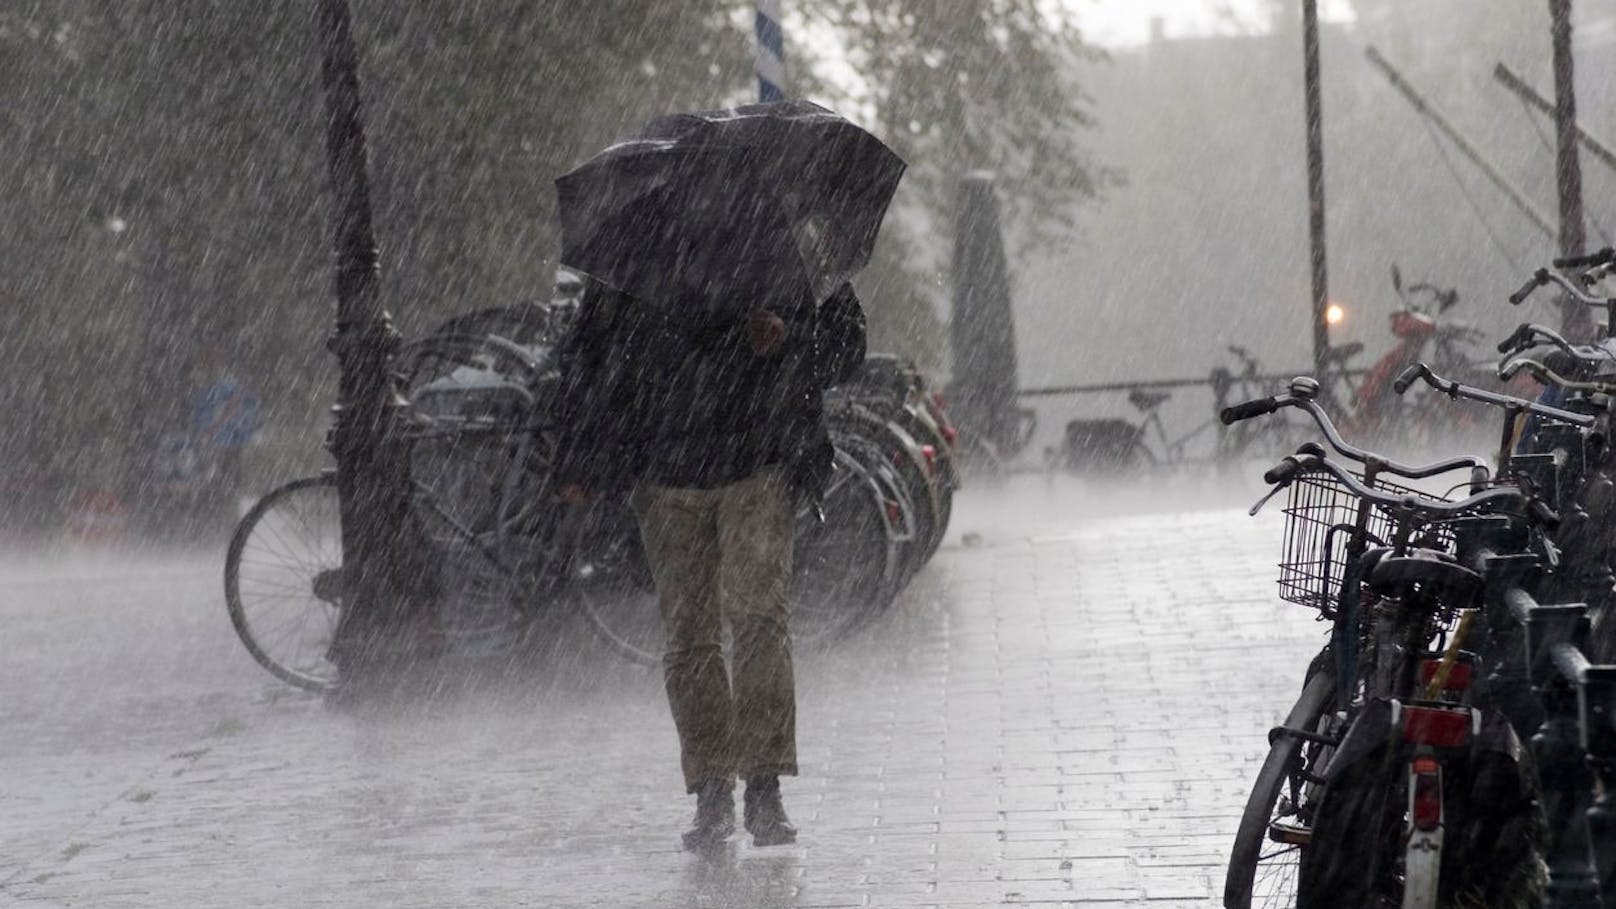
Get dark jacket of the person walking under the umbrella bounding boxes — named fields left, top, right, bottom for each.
left=556, top=281, right=865, bottom=498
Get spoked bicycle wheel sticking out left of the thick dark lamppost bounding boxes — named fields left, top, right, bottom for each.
left=225, top=476, right=346, bottom=691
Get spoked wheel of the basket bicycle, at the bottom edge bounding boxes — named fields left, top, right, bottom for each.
left=1223, top=671, right=1335, bottom=909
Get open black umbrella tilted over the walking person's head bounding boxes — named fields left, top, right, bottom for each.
left=556, top=100, right=903, bottom=314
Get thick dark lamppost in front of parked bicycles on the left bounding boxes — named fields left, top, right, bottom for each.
left=317, top=0, right=435, bottom=687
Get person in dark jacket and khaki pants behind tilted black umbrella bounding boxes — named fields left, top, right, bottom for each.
left=554, top=102, right=903, bottom=849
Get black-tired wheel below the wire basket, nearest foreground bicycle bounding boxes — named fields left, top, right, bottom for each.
left=1223, top=671, right=1335, bottom=909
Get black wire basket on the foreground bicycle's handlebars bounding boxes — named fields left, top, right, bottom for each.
left=1280, top=474, right=1453, bottom=613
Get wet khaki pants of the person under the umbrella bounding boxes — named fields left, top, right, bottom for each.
left=633, top=467, right=797, bottom=793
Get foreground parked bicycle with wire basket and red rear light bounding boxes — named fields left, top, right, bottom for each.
left=1223, top=372, right=1556, bottom=909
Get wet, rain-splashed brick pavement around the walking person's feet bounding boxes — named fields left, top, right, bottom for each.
left=0, top=484, right=1322, bottom=909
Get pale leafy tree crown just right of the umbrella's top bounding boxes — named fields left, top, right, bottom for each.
left=798, top=0, right=1118, bottom=262
